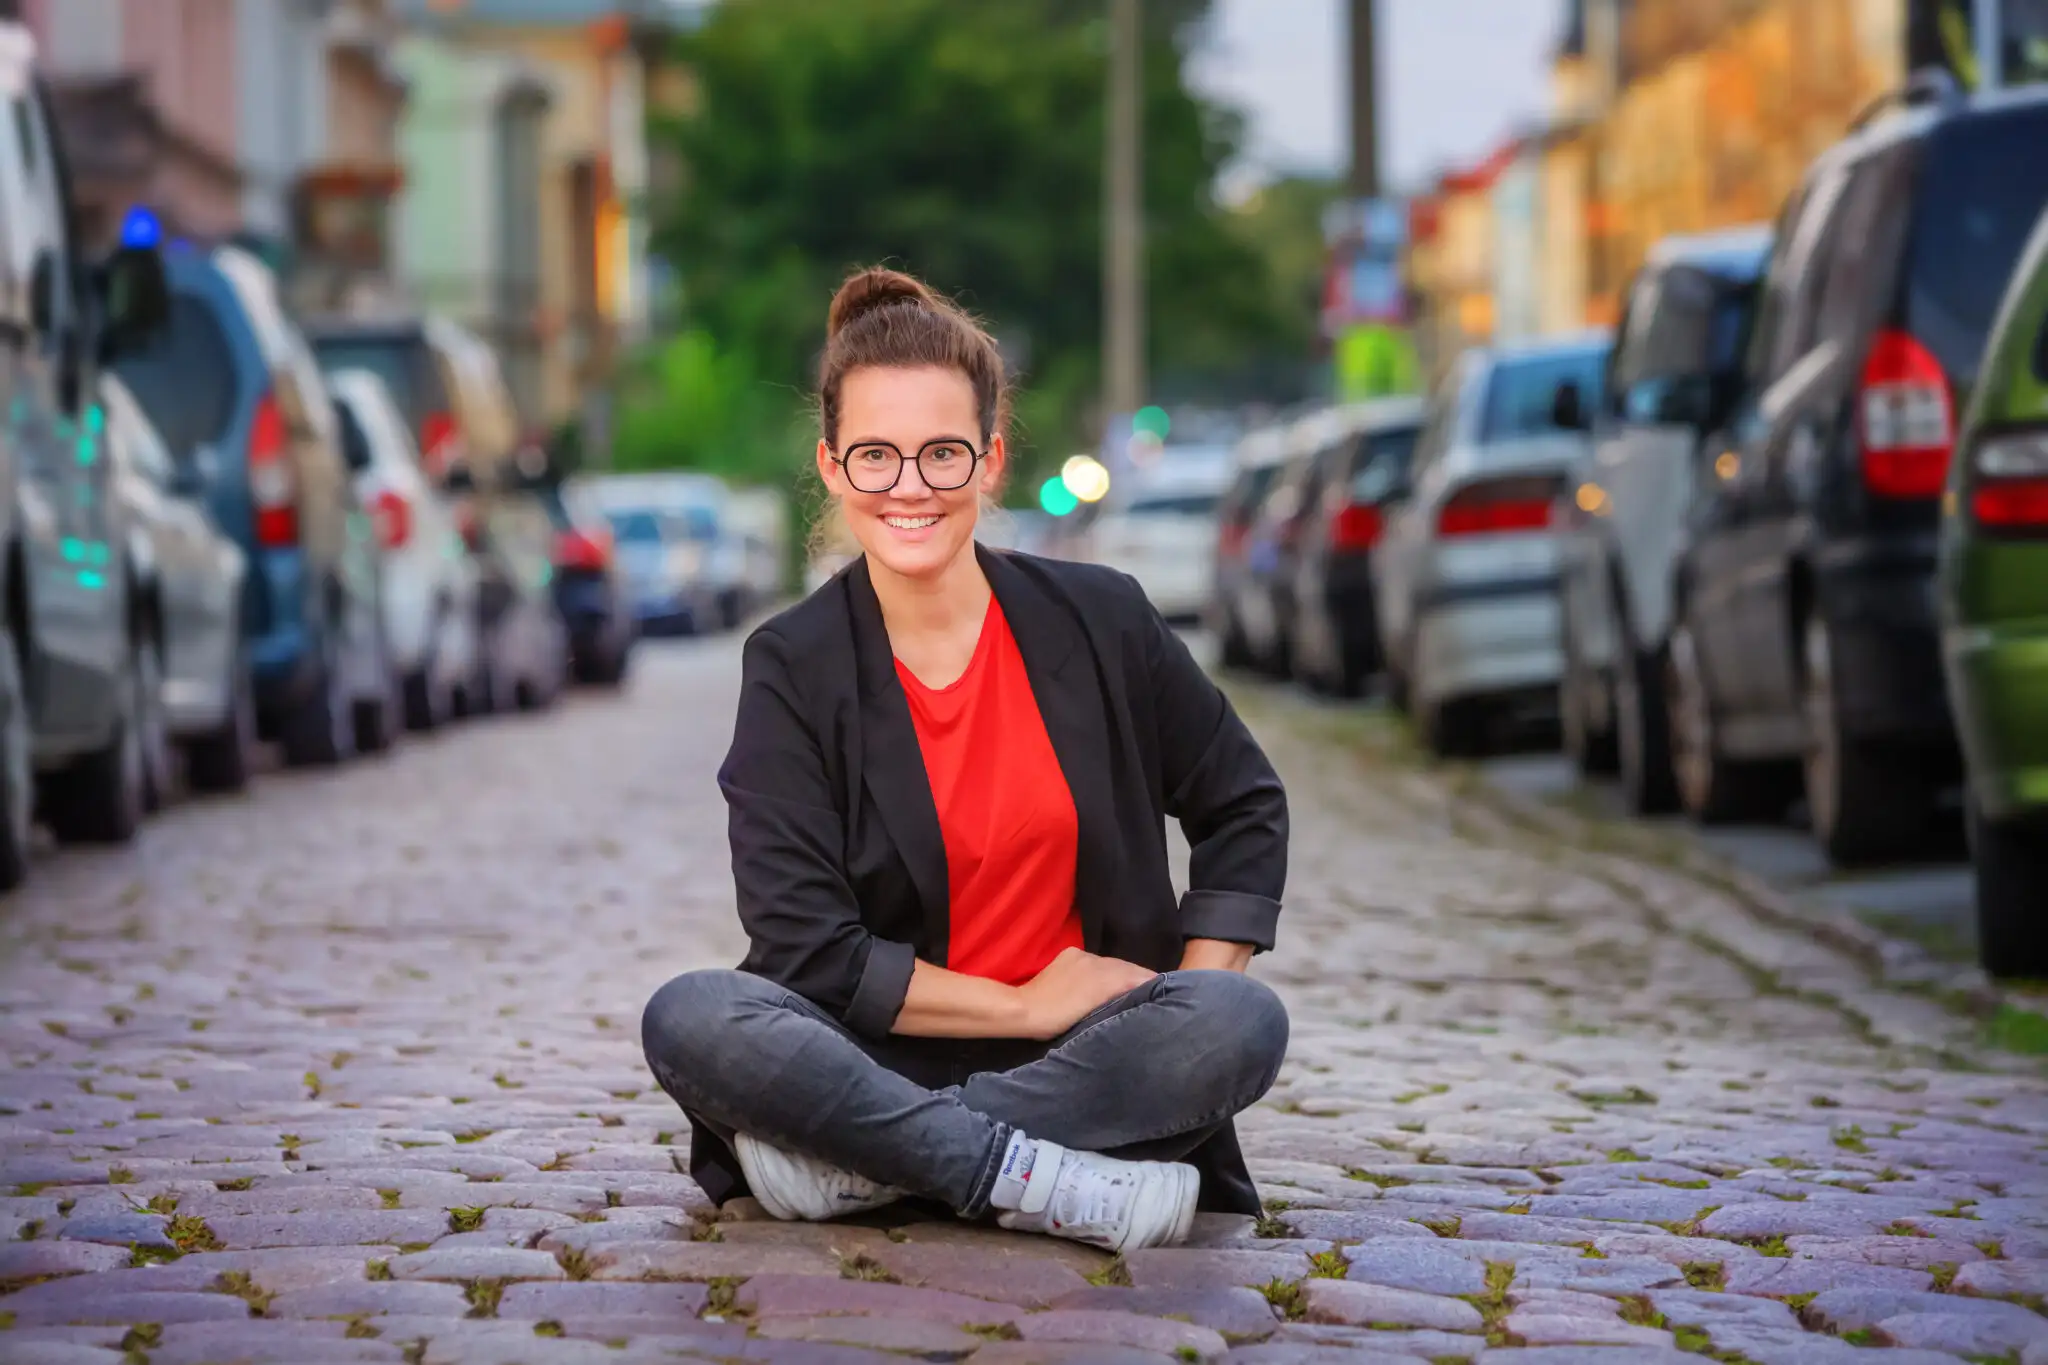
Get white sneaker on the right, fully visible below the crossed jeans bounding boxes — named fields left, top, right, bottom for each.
left=995, top=1140, right=1202, bottom=1252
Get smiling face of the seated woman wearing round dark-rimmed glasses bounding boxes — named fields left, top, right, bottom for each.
left=817, top=368, right=1004, bottom=579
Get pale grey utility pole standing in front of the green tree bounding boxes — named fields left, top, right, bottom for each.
left=1102, top=0, right=1145, bottom=421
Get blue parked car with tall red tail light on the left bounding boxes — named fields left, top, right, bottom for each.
left=117, top=244, right=399, bottom=765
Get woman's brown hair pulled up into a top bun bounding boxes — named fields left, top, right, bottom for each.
left=817, top=266, right=1010, bottom=446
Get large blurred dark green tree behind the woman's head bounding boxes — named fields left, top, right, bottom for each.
left=653, top=0, right=1298, bottom=497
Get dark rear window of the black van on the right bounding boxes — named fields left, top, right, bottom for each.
left=1907, top=108, right=2048, bottom=385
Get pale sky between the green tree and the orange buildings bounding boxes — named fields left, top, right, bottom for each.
left=1194, top=0, right=1565, bottom=199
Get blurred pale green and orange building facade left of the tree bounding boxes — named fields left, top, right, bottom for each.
left=397, top=0, right=690, bottom=432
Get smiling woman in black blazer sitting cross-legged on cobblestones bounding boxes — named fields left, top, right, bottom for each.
left=641, top=261, right=1288, bottom=1250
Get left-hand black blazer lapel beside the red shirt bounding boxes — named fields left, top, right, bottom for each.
left=846, top=557, right=952, bottom=966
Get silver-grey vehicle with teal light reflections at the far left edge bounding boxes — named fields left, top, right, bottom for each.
left=0, top=23, right=176, bottom=888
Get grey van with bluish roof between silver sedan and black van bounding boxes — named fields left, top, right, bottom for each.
left=1559, top=227, right=1772, bottom=814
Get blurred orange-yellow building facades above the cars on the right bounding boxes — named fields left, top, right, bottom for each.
left=1409, top=0, right=2048, bottom=375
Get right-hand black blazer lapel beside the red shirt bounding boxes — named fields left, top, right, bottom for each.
left=977, top=546, right=1120, bottom=952
